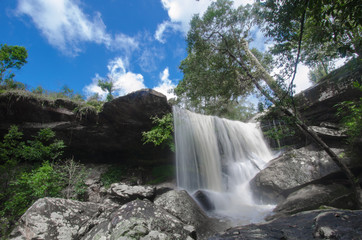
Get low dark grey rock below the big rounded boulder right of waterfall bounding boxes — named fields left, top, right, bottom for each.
left=274, top=184, right=354, bottom=218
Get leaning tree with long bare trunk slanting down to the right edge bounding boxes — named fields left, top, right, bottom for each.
left=184, top=0, right=362, bottom=207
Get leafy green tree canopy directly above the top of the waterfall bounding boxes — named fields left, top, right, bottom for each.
left=175, top=0, right=272, bottom=116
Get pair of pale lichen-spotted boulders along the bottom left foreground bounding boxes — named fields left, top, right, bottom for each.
left=10, top=198, right=196, bottom=240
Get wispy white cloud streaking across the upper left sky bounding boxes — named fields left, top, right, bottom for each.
left=17, top=0, right=138, bottom=55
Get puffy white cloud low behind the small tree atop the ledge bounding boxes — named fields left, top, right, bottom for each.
left=83, top=57, right=146, bottom=99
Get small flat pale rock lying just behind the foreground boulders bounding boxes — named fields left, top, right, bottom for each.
left=107, top=183, right=155, bottom=204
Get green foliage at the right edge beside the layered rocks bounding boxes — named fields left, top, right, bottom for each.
left=336, top=82, right=362, bottom=143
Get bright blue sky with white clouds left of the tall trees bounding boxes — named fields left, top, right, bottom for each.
left=0, top=0, right=314, bottom=97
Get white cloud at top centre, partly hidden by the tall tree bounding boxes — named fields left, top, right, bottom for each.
left=155, top=0, right=254, bottom=43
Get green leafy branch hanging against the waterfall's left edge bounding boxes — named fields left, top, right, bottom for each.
left=142, top=113, right=175, bottom=151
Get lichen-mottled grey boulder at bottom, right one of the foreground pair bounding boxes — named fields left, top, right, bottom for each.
left=82, top=200, right=195, bottom=240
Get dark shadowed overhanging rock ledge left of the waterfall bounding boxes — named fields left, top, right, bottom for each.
left=0, top=89, right=171, bottom=164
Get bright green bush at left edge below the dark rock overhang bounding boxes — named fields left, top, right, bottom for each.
left=0, top=126, right=65, bottom=235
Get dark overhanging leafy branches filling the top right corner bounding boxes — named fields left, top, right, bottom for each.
left=259, top=0, right=362, bottom=74
